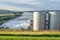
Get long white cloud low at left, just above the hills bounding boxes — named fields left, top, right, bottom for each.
left=0, top=5, right=32, bottom=11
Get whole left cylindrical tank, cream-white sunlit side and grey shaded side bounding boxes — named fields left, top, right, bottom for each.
left=33, top=11, right=45, bottom=31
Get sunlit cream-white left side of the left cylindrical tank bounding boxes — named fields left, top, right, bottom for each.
left=33, top=12, right=40, bottom=31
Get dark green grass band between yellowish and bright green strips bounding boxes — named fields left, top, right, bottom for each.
left=0, top=34, right=60, bottom=37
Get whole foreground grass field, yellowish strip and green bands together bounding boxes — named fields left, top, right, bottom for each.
left=0, top=30, right=60, bottom=40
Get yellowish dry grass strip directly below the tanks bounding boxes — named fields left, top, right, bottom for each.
left=0, top=30, right=60, bottom=34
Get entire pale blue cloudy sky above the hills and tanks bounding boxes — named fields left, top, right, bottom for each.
left=0, top=0, right=60, bottom=11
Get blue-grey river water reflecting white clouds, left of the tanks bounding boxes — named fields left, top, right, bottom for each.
left=1, top=12, right=33, bottom=29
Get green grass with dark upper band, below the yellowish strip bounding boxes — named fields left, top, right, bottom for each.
left=0, top=34, right=60, bottom=40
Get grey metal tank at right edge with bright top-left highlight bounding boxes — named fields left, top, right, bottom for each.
left=49, top=11, right=60, bottom=30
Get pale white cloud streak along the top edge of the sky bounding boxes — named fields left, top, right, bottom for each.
left=1, top=0, right=43, bottom=6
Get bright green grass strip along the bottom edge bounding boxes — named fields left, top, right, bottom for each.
left=0, top=36, right=60, bottom=40
